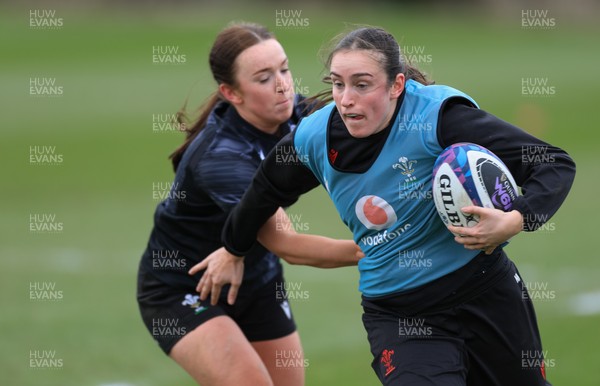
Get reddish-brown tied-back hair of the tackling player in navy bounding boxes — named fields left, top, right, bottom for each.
left=169, top=22, right=275, bottom=170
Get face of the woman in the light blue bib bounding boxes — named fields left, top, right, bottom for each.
left=330, top=50, right=404, bottom=138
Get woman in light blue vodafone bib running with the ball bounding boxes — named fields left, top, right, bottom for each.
left=191, top=28, right=575, bottom=386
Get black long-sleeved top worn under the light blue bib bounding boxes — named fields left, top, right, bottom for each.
left=222, top=96, right=575, bottom=256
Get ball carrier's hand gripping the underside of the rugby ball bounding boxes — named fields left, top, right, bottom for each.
left=448, top=206, right=523, bottom=255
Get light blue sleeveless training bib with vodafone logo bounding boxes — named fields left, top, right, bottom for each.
left=294, top=80, right=479, bottom=297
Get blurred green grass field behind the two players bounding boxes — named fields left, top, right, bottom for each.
left=0, top=3, right=600, bottom=386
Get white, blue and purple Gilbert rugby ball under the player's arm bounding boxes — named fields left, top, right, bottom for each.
left=432, top=143, right=519, bottom=227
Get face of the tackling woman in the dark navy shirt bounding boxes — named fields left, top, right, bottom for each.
left=227, top=39, right=294, bottom=134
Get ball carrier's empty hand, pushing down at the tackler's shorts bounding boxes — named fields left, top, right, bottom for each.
left=188, top=247, right=244, bottom=305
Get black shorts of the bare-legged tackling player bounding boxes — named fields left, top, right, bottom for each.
left=137, top=267, right=296, bottom=355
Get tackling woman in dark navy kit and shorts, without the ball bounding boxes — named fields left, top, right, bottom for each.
left=137, top=24, right=362, bottom=386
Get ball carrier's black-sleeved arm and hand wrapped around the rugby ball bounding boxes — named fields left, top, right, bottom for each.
left=437, top=102, right=575, bottom=253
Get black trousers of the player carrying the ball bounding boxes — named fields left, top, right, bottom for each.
left=363, top=253, right=549, bottom=386
